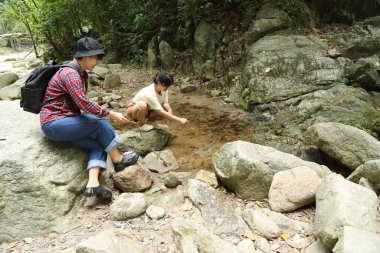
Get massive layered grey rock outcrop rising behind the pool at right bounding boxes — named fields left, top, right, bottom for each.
left=232, top=17, right=380, bottom=155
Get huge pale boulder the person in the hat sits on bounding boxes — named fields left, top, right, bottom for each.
left=0, top=101, right=87, bottom=243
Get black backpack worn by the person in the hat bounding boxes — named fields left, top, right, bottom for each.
left=20, top=61, right=80, bottom=114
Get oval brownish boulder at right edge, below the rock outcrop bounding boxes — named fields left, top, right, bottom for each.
left=306, top=122, right=380, bottom=171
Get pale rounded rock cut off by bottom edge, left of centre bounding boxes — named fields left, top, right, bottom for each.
left=75, top=229, right=146, bottom=253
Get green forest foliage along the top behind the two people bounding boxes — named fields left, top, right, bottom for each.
left=0, top=0, right=262, bottom=63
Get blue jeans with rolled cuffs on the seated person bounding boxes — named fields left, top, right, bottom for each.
left=42, top=114, right=120, bottom=170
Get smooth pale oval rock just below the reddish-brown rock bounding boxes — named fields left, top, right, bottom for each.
left=110, top=193, right=148, bottom=220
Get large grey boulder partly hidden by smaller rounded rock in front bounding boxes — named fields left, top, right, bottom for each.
left=212, top=141, right=330, bottom=200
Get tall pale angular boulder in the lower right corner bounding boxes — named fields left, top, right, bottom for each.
left=315, top=174, right=379, bottom=250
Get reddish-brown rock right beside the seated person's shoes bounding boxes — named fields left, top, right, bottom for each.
left=112, top=162, right=153, bottom=192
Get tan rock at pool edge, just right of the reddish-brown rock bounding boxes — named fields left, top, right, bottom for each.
left=144, top=149, right=179, bottom=173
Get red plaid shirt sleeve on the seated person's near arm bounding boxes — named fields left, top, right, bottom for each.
left=62, top=68, right=109, bottom=118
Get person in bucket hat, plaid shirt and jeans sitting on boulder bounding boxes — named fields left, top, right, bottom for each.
left=40, top=37, right=139, bottom=200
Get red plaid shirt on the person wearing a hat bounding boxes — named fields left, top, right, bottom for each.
left=40, top=59, right=109, bottom=126
